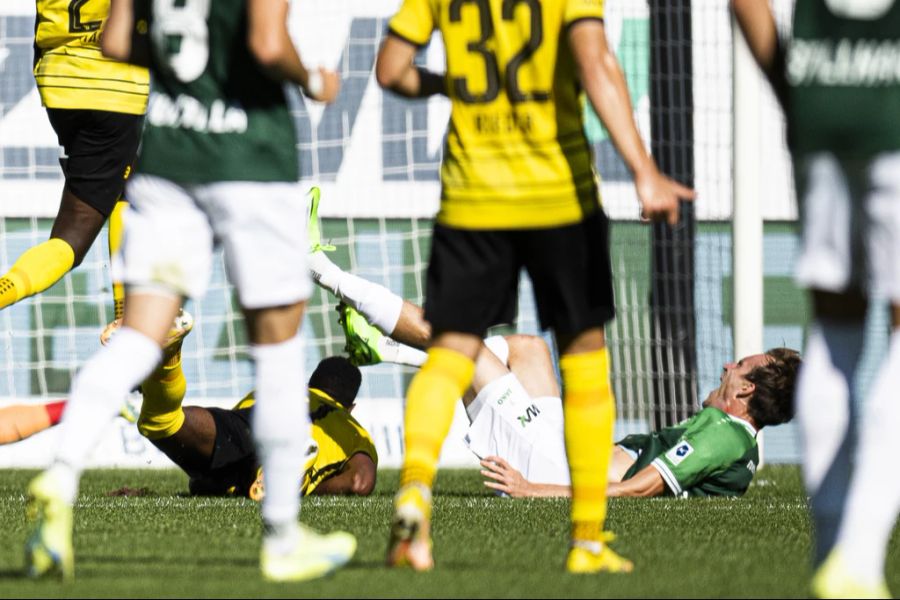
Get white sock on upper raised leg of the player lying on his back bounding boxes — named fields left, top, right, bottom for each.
left=309, top=252, right=403, bottom=335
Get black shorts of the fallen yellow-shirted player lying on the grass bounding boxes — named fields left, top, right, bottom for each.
left=188, top=407, right=259, bottom=496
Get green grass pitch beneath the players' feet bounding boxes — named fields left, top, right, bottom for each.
left=0, top=467, right=900, bottom=598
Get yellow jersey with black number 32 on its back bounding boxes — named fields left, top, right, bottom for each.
left=390, top=0, right=603, bottom=229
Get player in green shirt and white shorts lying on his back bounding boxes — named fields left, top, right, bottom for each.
left=308, top=194, right=800, bottom=496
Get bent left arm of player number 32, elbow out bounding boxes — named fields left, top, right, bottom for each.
left=375, top=33, right=447, bottom=98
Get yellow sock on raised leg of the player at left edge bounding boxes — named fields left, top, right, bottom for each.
left=0, top=238, right=75, bottom=308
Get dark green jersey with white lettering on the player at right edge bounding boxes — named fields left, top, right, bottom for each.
left=785, top=0, right=900, bottom=158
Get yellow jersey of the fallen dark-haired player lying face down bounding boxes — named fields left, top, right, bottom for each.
left=303, top=388, right=378, bottom=494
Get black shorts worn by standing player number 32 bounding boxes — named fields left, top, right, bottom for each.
left=425, top=211, right=615, bottom=337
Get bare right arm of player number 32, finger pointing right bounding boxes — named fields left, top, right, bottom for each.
left=569, top=19, right=696, bottom=225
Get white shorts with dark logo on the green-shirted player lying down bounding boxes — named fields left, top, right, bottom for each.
left=465, top=336, right=570, bottom=485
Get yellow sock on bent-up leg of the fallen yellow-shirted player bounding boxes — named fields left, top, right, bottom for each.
left=138, top=352, right=187, bottom=440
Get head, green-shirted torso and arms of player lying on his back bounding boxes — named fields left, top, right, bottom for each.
left=481, top=348, right=800, bottom=498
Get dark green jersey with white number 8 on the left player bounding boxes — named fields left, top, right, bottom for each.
left=135, top=0, right=299, bottom=184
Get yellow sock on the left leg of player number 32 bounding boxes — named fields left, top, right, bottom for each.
left=400, top=348, right=475, bottom=488
